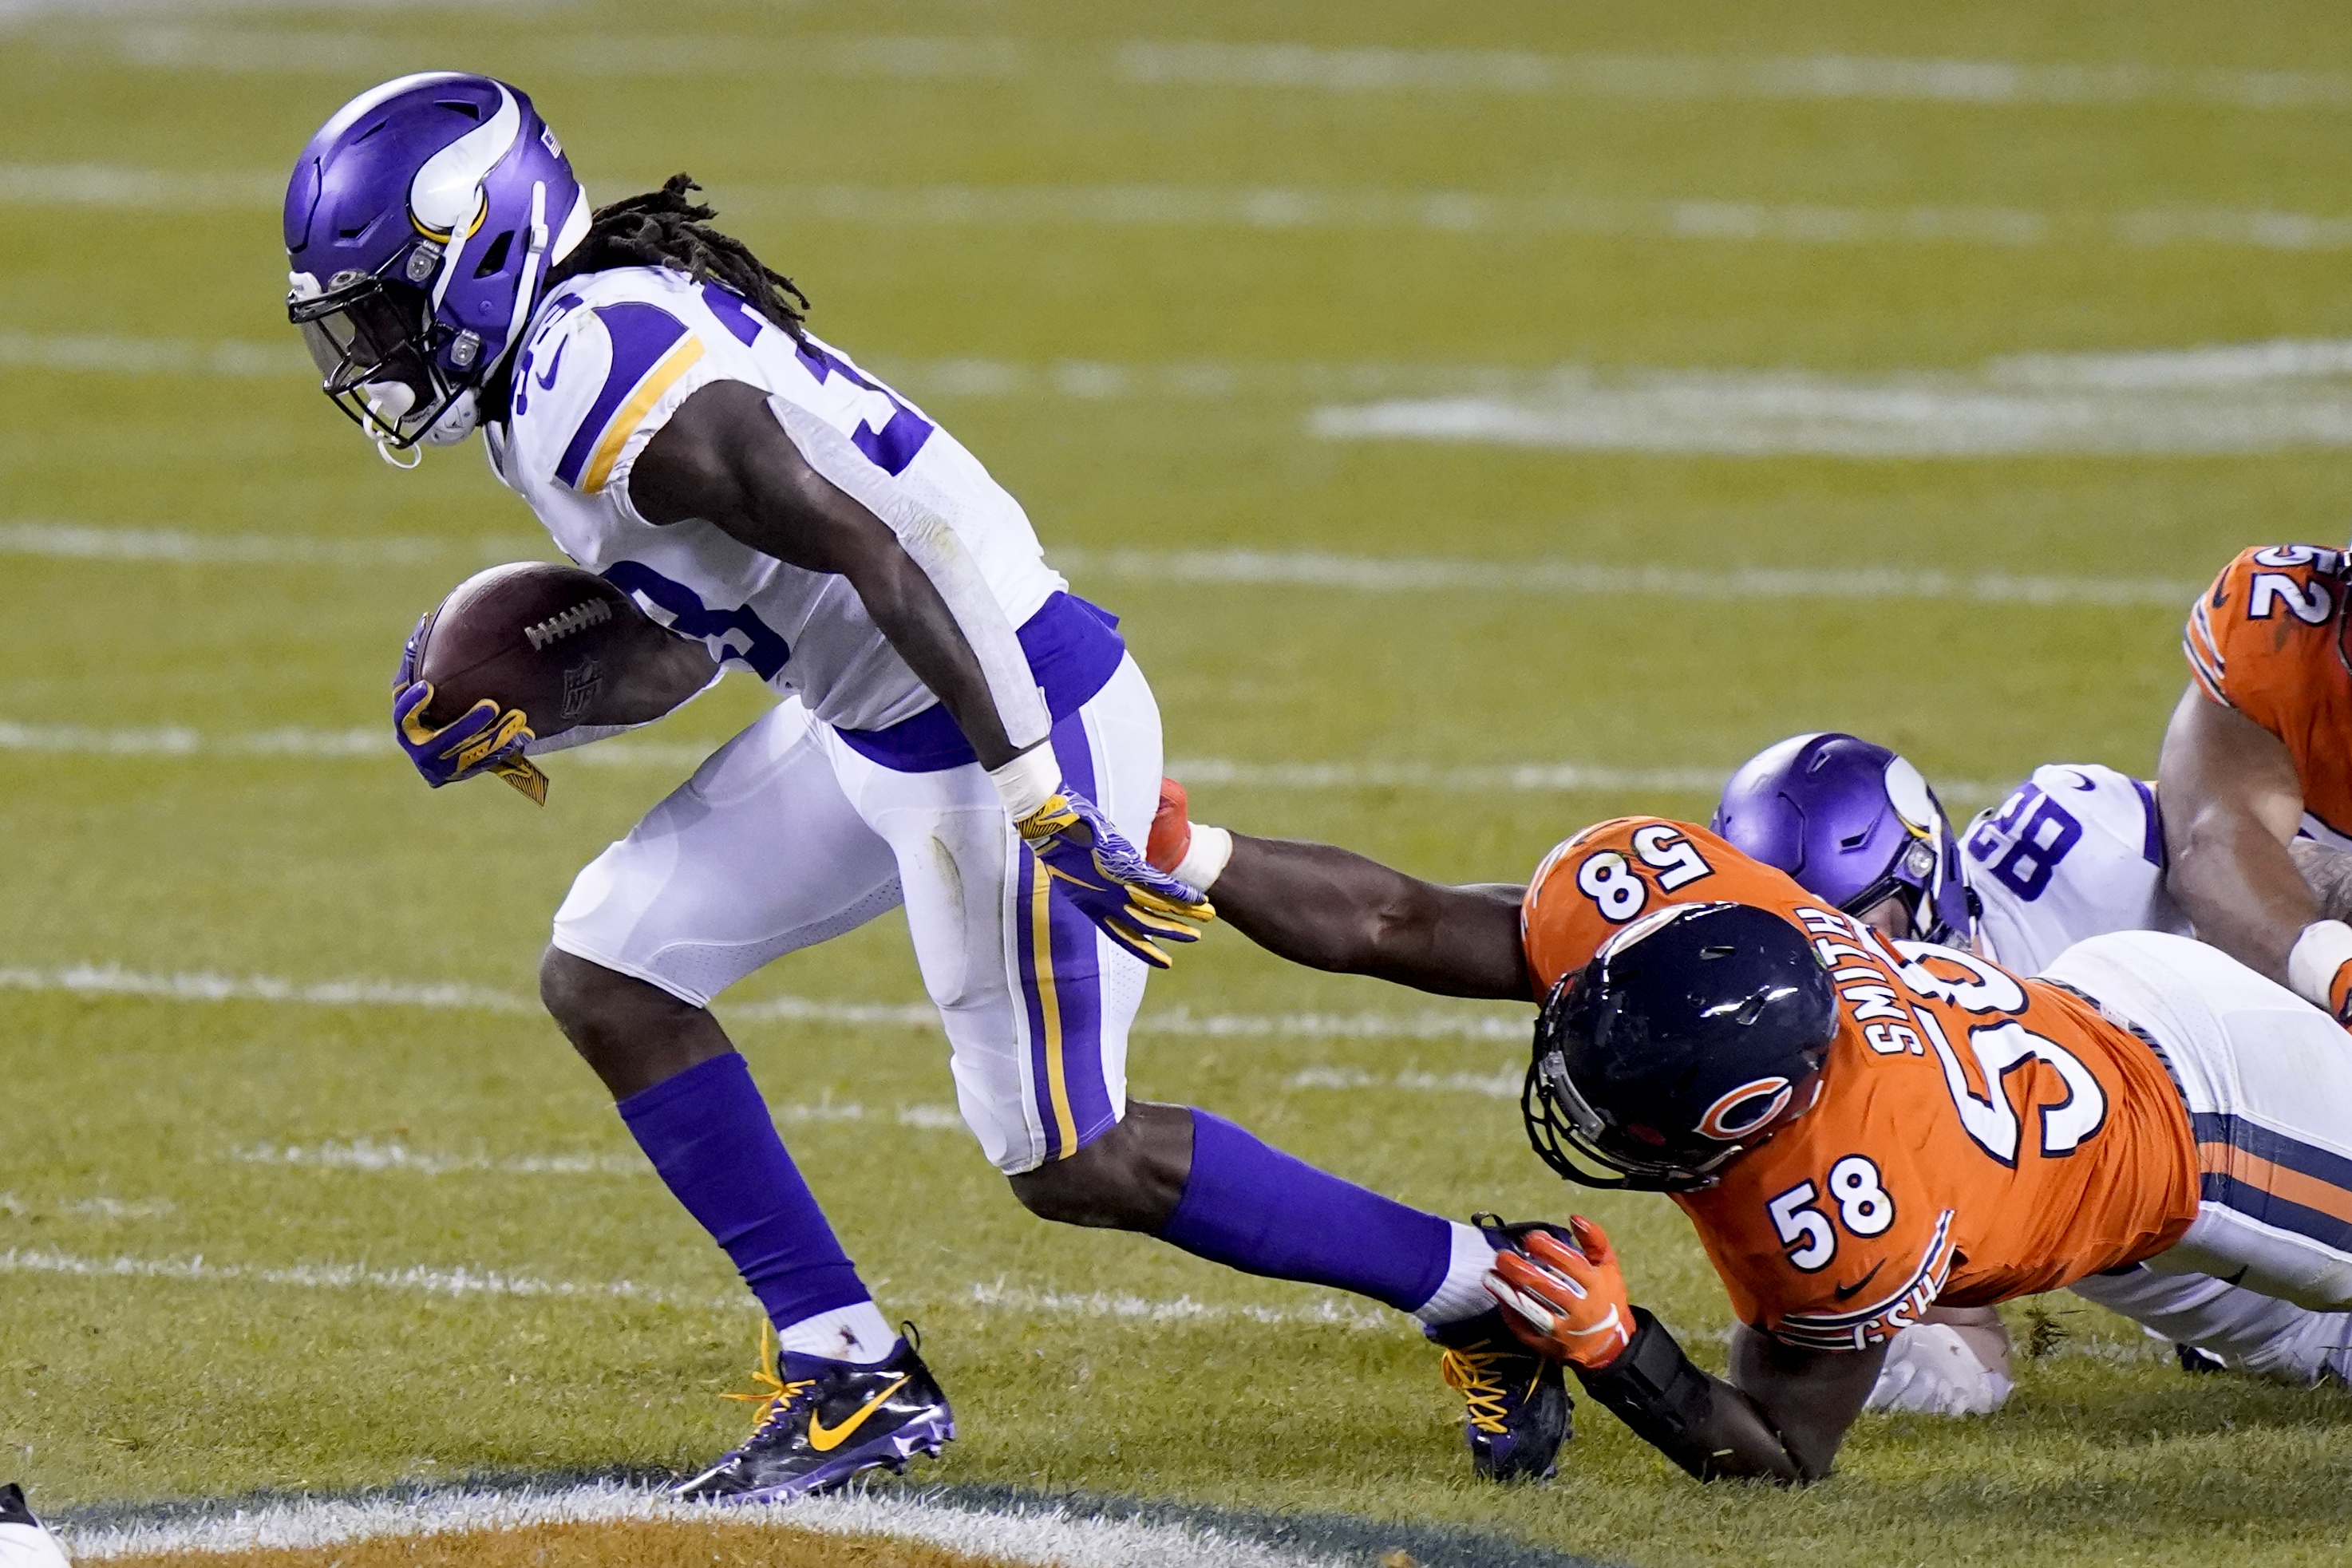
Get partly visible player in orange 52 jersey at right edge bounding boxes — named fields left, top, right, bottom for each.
left=2156, top=545, right=2352, bottom=1023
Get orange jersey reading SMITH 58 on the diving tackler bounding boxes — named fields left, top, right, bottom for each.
left=1522, top=818, right=2196, bottom=1349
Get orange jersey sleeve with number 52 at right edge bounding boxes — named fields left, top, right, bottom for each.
left=2180, top=545, right=2352, bottom=839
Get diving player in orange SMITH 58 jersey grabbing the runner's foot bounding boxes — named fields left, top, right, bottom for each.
left=1164, top=818, right=2352, bottom=1481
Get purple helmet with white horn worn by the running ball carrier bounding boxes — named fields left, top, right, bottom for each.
left=285, top=70, right=588, bottom=460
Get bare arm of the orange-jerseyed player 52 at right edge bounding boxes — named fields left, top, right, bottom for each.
left=2156, top=684, right=2323, bottom=999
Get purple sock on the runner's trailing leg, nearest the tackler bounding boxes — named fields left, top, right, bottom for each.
left=1160, top=1110, right=1453, bottom=1312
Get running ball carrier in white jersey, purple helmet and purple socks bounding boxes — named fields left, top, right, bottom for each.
left=285, top=73, right=1569, bottom=1500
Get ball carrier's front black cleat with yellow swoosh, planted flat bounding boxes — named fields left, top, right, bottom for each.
left=675, top=1324, right=955, bottom=1503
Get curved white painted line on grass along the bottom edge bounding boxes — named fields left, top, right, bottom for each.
left=59, top=1481, right=1353, bottom=1568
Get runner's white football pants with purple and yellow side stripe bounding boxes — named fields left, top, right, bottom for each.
left=555, top=658, right=1160, bottom=1175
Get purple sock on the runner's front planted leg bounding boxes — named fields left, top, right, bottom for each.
left=616, top=1051, right=870, bottom=1329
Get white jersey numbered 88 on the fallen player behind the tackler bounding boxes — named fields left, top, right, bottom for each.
left=1962, top=762, right=2190, bottom=976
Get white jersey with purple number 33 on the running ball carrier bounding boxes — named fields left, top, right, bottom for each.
left=489, top=268, right=1065, bottom=729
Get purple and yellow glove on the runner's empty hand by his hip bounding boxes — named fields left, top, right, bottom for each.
left=990, top=745, right=1216, bottom=969
